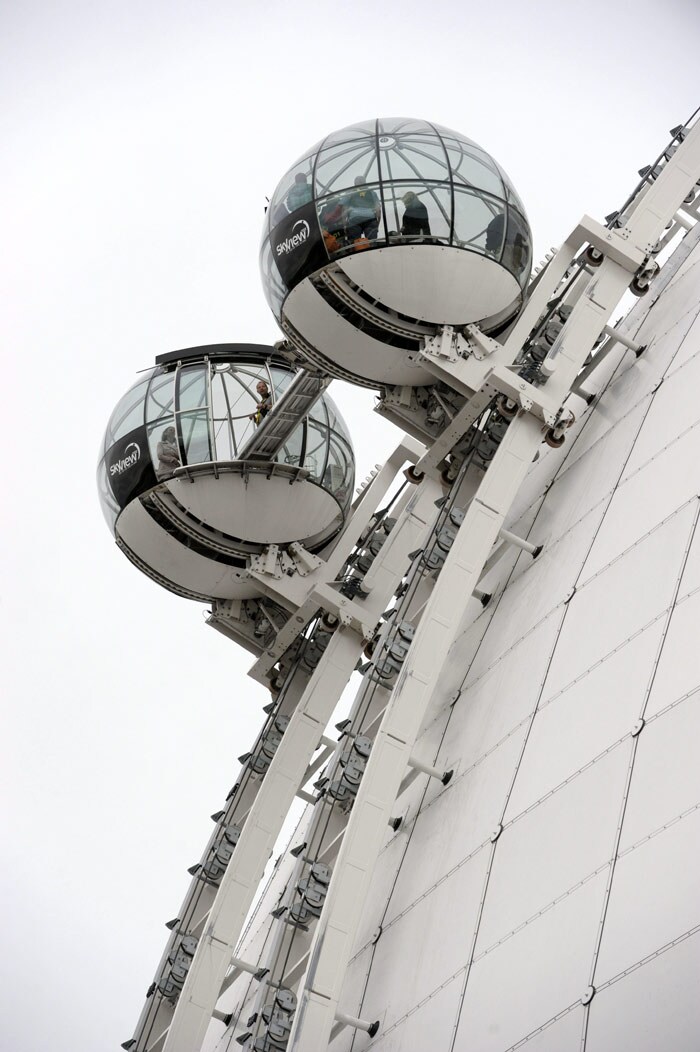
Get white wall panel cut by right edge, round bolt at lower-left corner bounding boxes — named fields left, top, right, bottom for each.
left=594, top=810, right=700, bottom=986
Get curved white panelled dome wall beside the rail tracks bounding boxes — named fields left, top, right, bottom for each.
left=320, top=224, right=700, bottom=1052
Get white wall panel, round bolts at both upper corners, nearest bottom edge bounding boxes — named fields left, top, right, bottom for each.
left=476, top=742, right=631, bottom=957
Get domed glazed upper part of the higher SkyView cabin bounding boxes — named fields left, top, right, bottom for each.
left=261, top=117, right=532, bottom=320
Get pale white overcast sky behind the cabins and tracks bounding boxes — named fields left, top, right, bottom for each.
left=0, top=0, right=700, bottom=1052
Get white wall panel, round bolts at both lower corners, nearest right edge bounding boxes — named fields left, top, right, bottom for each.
left=506, top=621, right=663, bottom=820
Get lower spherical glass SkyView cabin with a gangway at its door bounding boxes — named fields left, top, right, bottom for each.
left=97, top=344, right=355, bottom=601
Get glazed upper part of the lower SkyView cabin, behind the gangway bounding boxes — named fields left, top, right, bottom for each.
left=97, top=355, right=354, bottom=530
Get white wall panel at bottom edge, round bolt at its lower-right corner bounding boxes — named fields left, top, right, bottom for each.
left=452, top=873, right=605, bottom=1052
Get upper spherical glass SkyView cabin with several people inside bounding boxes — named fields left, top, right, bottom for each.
left=260, top=118, right=532, bottom=387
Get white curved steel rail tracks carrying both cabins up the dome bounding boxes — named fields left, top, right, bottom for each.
left=123, top=115, right=700, bottom=1052
